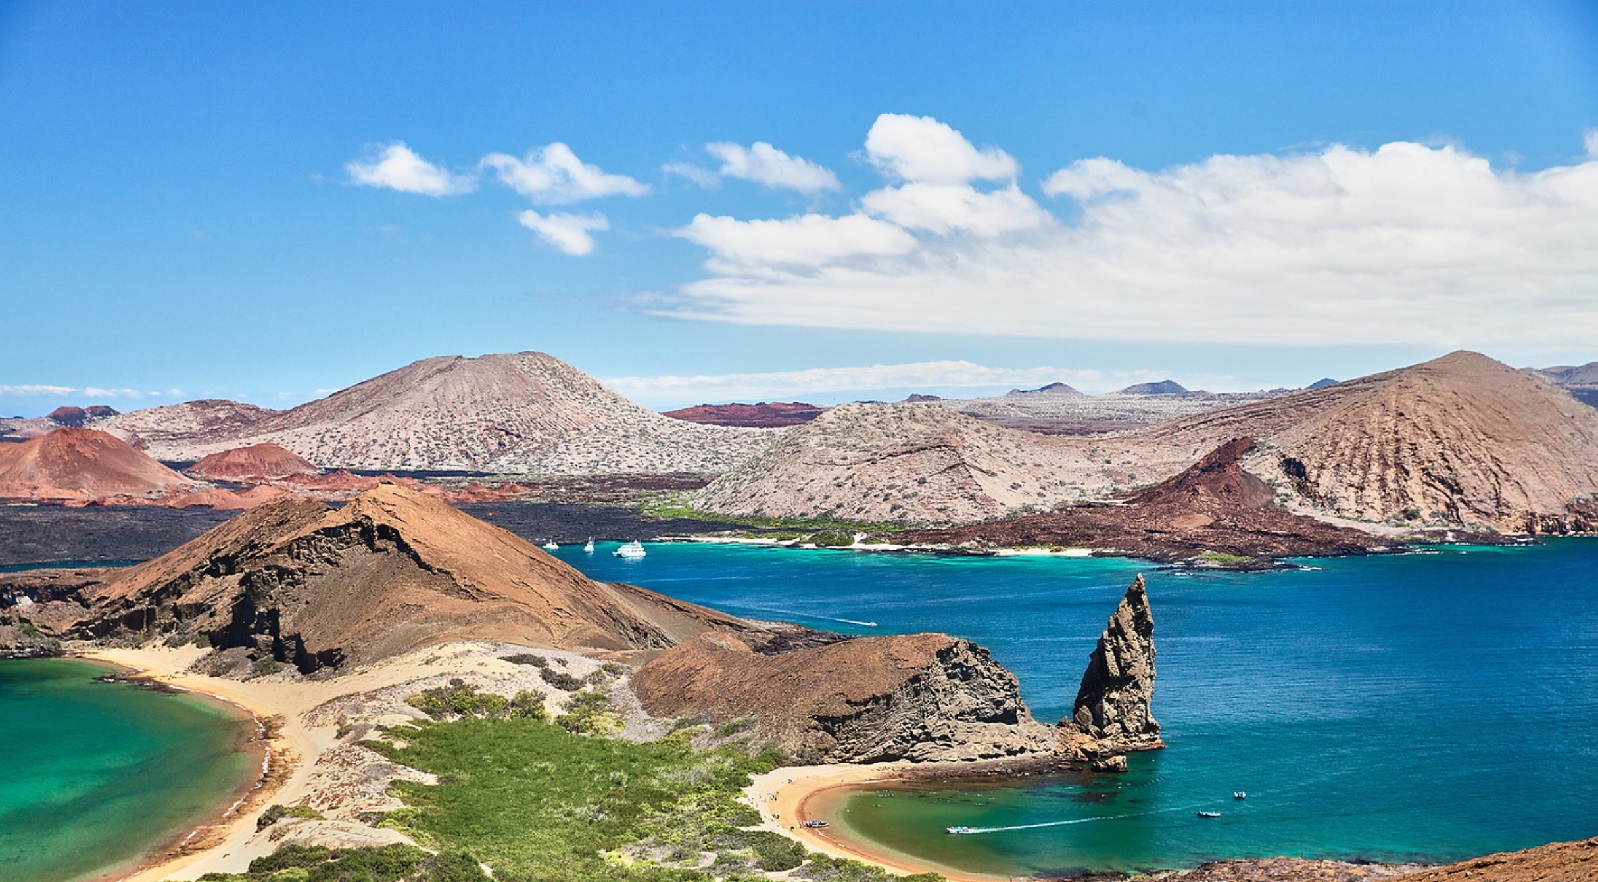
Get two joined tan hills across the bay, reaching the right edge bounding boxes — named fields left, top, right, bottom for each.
left=698, top=352, right=1598, bottom=532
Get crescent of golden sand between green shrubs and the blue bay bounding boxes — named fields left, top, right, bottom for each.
left=743, top=762, right=1007, bottom=882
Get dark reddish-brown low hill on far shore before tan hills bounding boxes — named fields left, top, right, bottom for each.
left=893, top=438, right=1384, bottom=566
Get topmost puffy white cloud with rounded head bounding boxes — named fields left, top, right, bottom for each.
left=866, top=113, right=1021, bottom=184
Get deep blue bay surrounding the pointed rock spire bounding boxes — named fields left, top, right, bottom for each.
left=559, top=540, right=1598, bottom=872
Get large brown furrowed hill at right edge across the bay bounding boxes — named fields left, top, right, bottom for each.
left=1147, top=352, right=1598, bottom=532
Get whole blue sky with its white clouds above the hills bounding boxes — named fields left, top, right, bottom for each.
left=0, top=0, right=1598, bottom=415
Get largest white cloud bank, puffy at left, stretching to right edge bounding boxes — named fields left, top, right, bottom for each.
left=662, top=126, right=1598, bottom=352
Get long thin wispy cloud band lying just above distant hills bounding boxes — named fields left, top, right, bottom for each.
left=602, top=361, right=1201, bottom=401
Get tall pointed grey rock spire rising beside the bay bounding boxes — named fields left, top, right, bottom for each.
left=1061, top=574, right=1165, bottom=753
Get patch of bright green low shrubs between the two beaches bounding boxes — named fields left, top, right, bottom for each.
left=194, top=682, right=941, bottom=882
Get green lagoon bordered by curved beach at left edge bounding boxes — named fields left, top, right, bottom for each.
left=0, top=658, right=256, bottom=882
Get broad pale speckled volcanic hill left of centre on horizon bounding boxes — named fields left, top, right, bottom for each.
left=107, top=352, right=770, bottom=475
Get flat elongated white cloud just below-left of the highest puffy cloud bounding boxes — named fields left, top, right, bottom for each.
left=676, top=214, right=916, bottom=268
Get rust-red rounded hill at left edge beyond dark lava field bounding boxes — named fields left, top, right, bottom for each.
left=0, top=427, right=195, bottom=502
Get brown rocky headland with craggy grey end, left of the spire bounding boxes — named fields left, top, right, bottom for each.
left=633, top=634, right=1056, bottom=762
